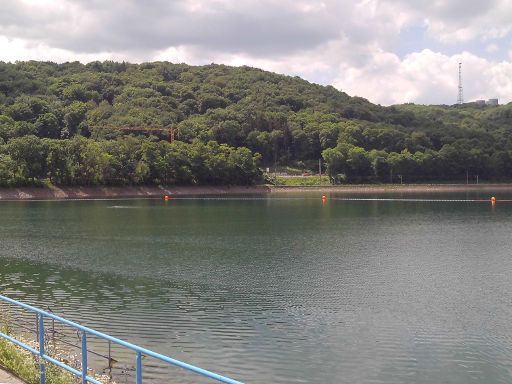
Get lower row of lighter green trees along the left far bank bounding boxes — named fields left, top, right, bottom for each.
left=0, top=136, right=261, bottom=187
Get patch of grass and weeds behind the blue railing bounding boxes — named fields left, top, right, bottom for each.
left=0, top=325, right=80, bottom=384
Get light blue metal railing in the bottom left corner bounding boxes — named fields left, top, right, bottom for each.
left=0, top=295, right=242, bottom=384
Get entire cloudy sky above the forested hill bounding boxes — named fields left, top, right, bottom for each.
left=0, top=0, right=512, bottom=105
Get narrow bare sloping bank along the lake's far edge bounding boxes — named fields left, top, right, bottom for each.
left=0, top=184, right=512, bottom=201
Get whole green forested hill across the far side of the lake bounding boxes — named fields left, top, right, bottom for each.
left=0, top=62, right=512, bottom=185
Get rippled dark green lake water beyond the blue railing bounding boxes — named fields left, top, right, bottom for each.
left=0, top=194, right=512, bottom=383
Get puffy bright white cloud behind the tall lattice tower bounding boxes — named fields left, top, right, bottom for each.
left=335, top=50, right=512, bottom=104
